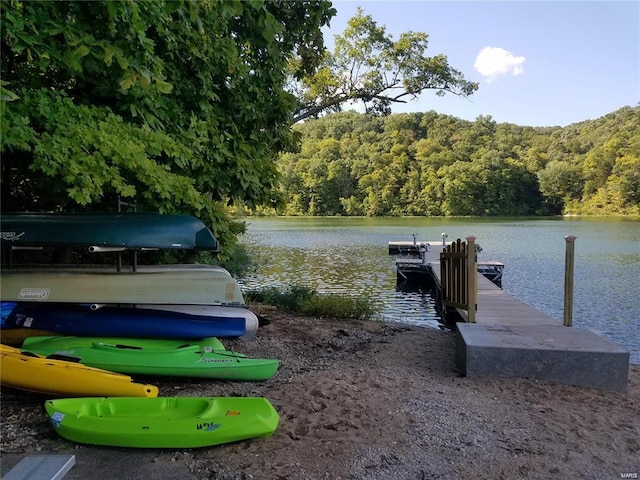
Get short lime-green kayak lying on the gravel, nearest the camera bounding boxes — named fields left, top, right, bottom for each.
left=45, top=397, right=280, bottom=448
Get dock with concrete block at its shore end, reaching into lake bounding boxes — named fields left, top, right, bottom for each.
left=390, top=241, right=629, bottom=392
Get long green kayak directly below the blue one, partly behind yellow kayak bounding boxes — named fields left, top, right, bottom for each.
left=22, top=337, right=280, bottom=381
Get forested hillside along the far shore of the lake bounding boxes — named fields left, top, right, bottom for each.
left=262, top=106, right=640, bottom=216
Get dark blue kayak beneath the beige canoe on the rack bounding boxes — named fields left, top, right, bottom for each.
left=2, top=302, right=246, bottom=339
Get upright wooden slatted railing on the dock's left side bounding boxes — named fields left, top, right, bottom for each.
left=440, top=236, right=478, bottom=323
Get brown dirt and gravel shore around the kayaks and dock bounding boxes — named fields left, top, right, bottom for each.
left=0, top=313, right=640, bottom=480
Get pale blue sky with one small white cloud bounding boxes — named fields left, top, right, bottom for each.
left=323, top=0, right=640, bottom=126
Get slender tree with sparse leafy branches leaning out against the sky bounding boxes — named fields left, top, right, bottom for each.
left=292, top=8, right=478, bottom=122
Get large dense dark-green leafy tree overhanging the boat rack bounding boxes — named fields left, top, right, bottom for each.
left=0, top=0, right=335, bottom=256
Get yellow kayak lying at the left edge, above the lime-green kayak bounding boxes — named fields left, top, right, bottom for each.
left=0, top=344, right=158, bottom=397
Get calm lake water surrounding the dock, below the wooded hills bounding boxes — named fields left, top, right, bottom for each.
left=240, top=217, right=640, bottom=364
